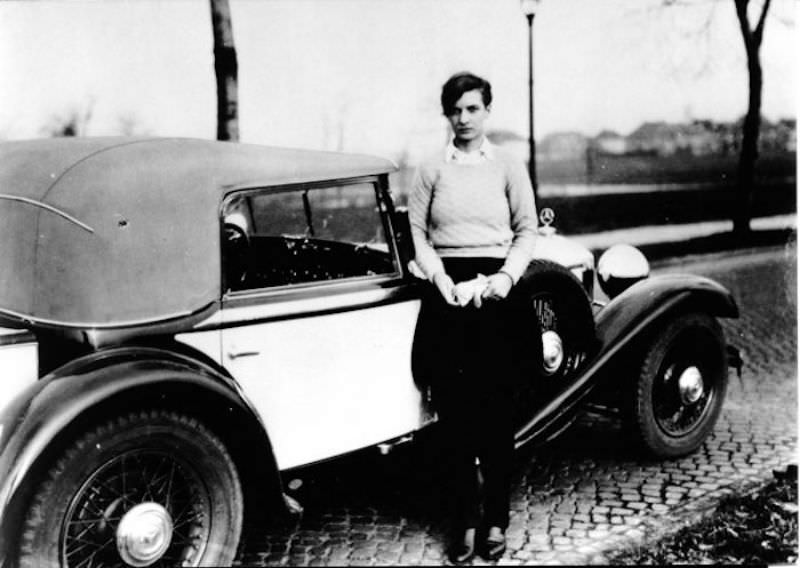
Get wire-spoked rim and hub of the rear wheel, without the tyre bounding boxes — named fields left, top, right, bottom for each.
left=60, top=449, right=211, bottom=566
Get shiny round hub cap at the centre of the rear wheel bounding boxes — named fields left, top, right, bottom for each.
left=117, top=503, right=172, bottom=566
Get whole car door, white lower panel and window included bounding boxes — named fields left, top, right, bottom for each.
left=216, top=178, right=430, bottom=469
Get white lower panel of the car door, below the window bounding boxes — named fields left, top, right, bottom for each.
left=222, top=294, right=430, bottom=470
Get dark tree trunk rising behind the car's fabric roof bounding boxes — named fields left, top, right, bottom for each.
left=210, top=0, right=239, bottom=141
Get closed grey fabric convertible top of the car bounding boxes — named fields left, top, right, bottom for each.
left=0, top=138, right=395, bottom=328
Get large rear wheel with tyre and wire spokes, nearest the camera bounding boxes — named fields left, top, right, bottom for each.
left=19, top=410, right=243, bottom=568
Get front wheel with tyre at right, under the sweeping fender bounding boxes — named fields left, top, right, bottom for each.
left=632, top=313, right=728, bottom=457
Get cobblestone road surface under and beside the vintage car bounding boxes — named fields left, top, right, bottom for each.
left=237, top=248, right=797, bottom=566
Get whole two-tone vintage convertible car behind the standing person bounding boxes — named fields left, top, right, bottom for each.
left=0, top=138, right=737, bottom=566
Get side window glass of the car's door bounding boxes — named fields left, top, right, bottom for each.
left=223, top=183, right=398, bottom=291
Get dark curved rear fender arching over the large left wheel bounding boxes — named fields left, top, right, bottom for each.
left=0, top=347, right=285, bottom=566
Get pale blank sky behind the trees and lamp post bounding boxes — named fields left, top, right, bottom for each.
left=0, top=0, right=800, bottom=159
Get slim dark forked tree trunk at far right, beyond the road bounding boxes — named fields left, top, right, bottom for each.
left=733, top=0, right=770, bottom=235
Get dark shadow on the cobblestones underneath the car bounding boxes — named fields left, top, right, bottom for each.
left=242, top=416, right=637, bottom=554
